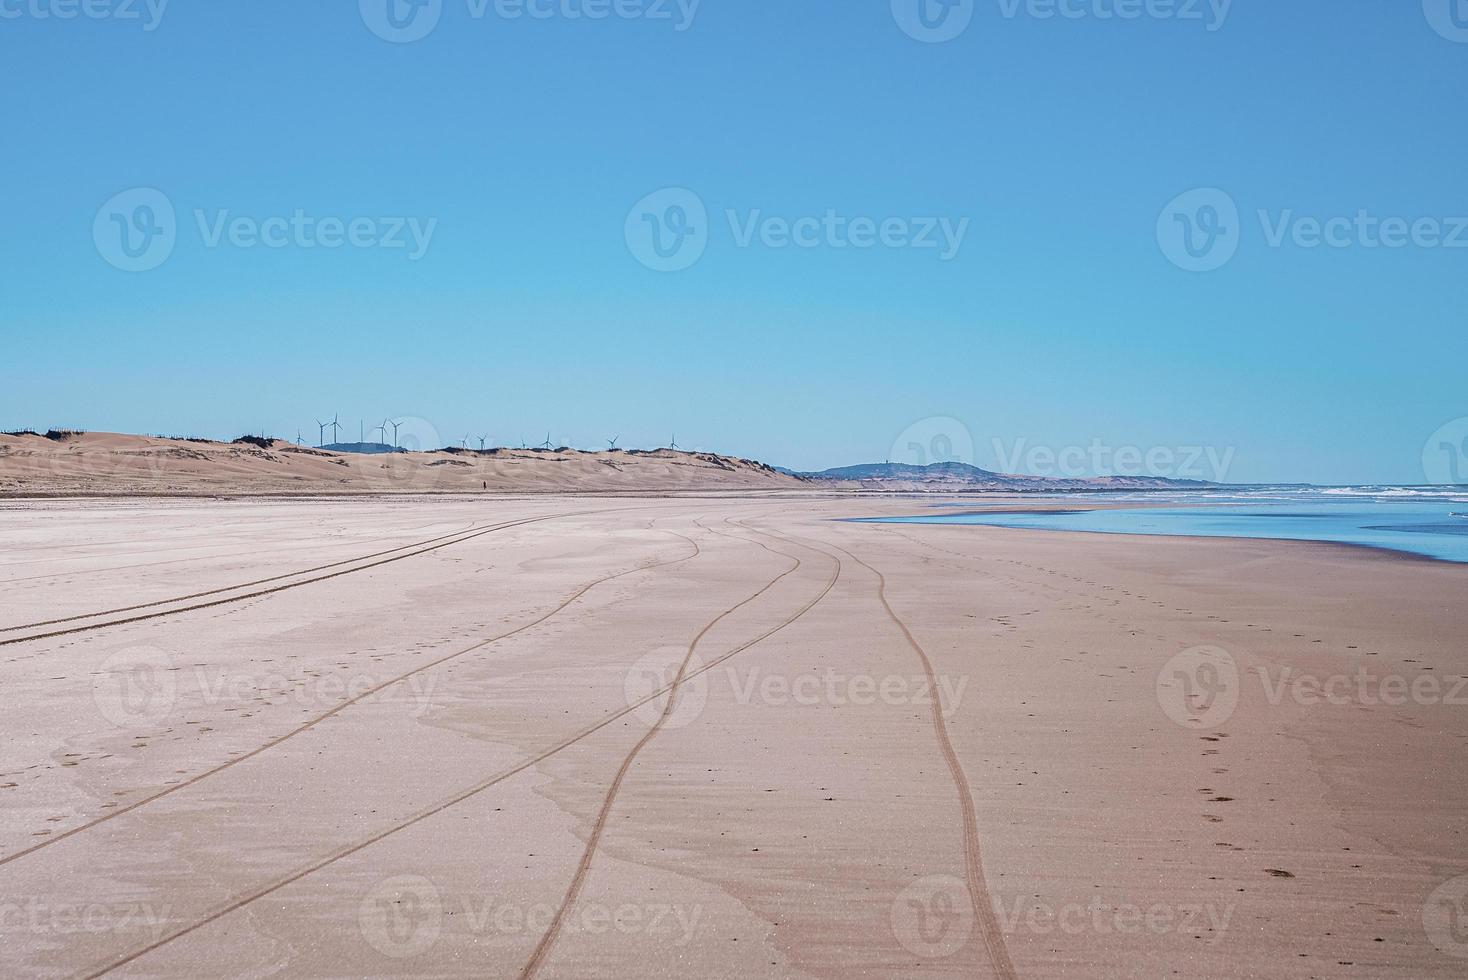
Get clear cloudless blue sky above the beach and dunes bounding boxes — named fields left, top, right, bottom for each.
left=0, top=0, right=1468, bottom=483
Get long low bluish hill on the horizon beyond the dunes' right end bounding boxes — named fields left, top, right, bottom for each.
left=797, top=462, right=1217, bottom=493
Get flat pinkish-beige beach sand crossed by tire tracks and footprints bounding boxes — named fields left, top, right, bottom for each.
left=0, top=494, right=1468, bottom=980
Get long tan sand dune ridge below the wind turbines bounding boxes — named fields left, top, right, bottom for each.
left=0, top=433, right=803, bottom=496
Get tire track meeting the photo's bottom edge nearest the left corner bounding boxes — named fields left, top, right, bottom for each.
left=82, top=516, right=840, bottom=980
